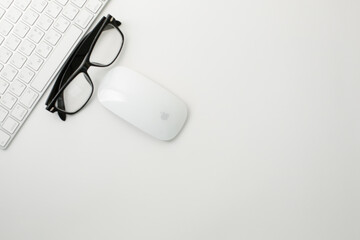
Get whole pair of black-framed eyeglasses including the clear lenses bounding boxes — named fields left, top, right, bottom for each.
left=46, top=15, right=124, bottom=121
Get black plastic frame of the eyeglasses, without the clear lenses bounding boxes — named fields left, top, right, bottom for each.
left=46, top=14, right=125, bottom=121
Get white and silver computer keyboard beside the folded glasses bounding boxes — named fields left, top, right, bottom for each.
left=0, top=0, right=109, bottom=149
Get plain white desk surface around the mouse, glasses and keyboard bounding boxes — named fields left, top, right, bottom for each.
left=0, top=0, right=360, bottom=240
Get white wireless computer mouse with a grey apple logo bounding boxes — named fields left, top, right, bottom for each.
left=98, top=67, right=188, bottom=141
